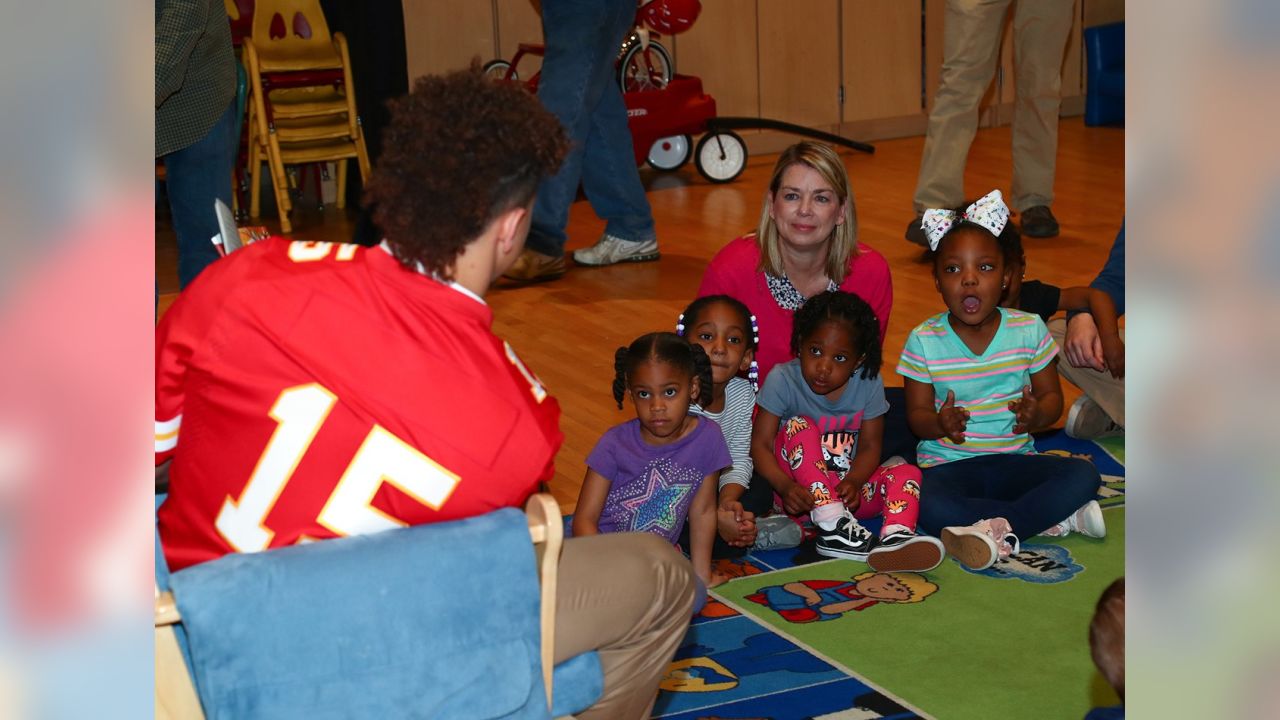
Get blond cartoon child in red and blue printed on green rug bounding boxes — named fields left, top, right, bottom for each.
left=746, top=573, right=938, bottom=623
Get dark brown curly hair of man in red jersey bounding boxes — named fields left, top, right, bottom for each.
left=364, top=64, right=568, bottom=281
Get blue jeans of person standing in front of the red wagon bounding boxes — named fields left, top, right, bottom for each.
left=526, top=0, right=655, bottom=256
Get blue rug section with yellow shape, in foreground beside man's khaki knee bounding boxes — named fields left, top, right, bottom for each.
left=653, top=615, right=915, bottom=720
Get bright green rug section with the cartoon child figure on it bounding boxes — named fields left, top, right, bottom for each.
left=713, top=507, right=1125, bottom=720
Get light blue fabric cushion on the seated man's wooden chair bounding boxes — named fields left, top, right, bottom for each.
left=170, top=509, right=550, bottom=719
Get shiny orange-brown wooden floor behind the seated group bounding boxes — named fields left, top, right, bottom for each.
left=156, top=118, right=1125, bottom=511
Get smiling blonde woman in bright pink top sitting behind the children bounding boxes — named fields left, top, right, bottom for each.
left=698, top=141, right=893, bottom=384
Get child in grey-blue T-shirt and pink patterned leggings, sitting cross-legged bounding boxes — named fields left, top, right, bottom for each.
left=751, top=291, right=943, bottom=571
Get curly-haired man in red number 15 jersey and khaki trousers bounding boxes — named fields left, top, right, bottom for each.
left=155, top=70, right=694, bottom=717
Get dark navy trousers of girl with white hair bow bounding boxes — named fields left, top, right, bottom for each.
left=919, top=454, right=1102, bottom=538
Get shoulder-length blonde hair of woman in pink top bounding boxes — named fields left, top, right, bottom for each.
left=755, top=140, right=858, bottom=284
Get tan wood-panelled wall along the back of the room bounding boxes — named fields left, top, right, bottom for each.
left=404, top=0, right=1090, bottom=147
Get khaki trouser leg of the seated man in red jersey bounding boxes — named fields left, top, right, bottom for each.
left=556, top=533, right=695, bottom=720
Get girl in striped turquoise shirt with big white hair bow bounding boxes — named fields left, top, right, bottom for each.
left=897, top=190, right=1106, bottom=570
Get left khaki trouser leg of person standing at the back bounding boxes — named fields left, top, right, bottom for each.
left=914, top=0, right=1010, bottom=213
